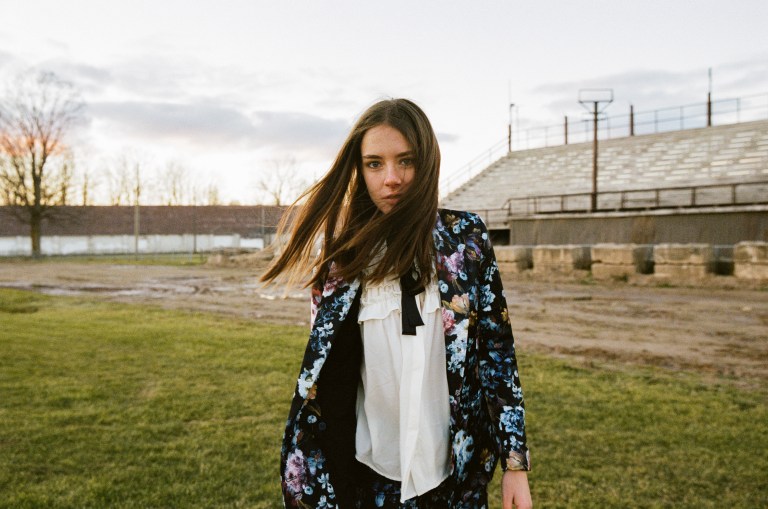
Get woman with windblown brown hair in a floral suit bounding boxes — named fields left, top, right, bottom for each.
left=262, top=99, right=531, bottom=509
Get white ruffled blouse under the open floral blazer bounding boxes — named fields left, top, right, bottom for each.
left=355, top=279, right=450, bottom=502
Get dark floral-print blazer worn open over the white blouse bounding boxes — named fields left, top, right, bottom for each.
left=280, top=209, right=530, bottom=509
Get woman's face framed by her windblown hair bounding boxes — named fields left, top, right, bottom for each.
left=360, top=124, right=416, bottom=214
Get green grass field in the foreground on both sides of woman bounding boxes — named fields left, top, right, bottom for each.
left=0, top=289, right=768, bottom=508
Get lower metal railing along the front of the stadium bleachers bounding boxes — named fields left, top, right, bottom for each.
left=504, top=180, right=768, bottom=215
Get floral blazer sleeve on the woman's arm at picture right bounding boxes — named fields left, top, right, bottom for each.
left=477, top=221, right=531, bottom=470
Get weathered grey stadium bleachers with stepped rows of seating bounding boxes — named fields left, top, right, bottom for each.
left=442, top=120, right=768, bottom=222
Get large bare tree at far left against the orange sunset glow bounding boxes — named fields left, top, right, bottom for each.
left=0, top=72, right=82, bottom=256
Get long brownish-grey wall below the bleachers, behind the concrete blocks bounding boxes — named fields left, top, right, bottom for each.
left=509, top=209, right=768, bottom=246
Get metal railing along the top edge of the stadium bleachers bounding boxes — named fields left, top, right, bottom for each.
left=440, top=94, right=768, bottom=196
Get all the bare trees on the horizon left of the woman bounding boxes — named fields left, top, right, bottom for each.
left=0, top=71, right=306, bottom=256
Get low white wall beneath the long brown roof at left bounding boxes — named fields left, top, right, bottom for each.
left=0, top=234, right=264, bottom=256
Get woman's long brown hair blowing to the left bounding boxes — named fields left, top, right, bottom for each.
left=261, top=99, right=440, bottom=285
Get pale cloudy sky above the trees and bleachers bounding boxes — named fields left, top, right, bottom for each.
left=0, top=0, right=768, bottom=204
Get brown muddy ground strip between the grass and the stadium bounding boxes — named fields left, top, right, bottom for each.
left=0, top=262, right=768, bottom=389
